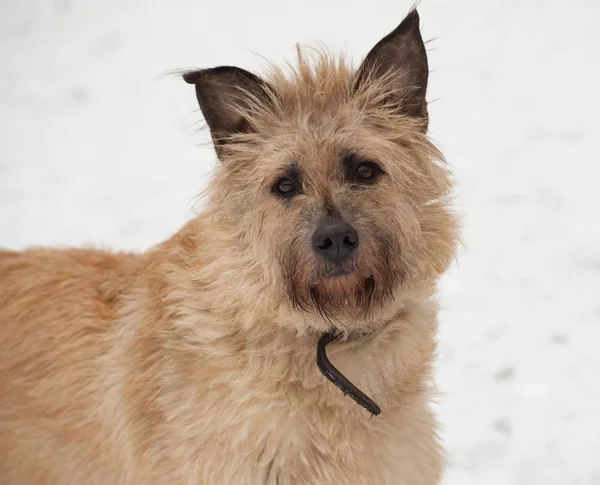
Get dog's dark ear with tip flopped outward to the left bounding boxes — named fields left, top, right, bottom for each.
left=183, top=66, right=269, bottom=149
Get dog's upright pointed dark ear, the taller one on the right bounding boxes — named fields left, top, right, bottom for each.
left=354, top=9, right=429, bottom=131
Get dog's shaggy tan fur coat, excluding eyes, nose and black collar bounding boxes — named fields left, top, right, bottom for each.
left=0, top=10, right=457, bottom=485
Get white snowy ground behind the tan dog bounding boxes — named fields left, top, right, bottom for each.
left=0, top=0, right=600, bottom=485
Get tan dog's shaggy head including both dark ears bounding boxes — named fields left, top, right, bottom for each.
left=184, top=11, right=456, bottom=325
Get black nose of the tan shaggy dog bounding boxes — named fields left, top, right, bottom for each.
left=312, top=216, right=358, bottom=263
